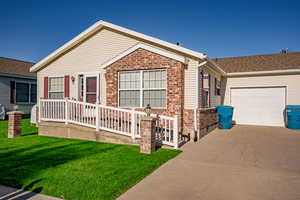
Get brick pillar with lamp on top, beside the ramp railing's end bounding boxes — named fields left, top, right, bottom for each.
left=140, top=116, right=157, bottom=154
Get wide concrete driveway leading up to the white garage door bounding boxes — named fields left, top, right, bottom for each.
left=119, top=126, right=300, bottom=200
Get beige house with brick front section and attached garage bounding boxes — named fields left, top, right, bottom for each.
left=31, top=21, right=300, bottom=145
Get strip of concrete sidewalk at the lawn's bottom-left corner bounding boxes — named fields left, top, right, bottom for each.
left=0, top=185, right=61, bottom=200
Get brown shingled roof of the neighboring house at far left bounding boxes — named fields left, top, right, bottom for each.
left=0, top=57, right=36, bottom=78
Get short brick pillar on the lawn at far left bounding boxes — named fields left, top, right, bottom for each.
left=7, top=111, right=24, bottom=138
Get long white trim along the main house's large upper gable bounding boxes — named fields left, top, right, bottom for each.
left=30, top=21, right=207, bottom=72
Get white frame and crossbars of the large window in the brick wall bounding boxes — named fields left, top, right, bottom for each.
left=118, top=69, right=168, bottom=109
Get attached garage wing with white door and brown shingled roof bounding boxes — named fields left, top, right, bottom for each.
left=214, top=52, right=300, bottom=126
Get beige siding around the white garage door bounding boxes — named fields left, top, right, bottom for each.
left=224, top=74, right=300, bottom=105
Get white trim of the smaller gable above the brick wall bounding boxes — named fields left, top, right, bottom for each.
left=101, top=43, right=185, bottom=68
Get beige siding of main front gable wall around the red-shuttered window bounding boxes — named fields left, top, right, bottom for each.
left=37, top=29, right=138, bottom=104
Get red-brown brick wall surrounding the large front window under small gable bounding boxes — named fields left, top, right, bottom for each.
left=105, top=49, right=185, bottom=117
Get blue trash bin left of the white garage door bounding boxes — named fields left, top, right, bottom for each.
left=216, top=106, right=233, bottom=129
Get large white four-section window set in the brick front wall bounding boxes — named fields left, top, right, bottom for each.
left=119, top=70, right=166, bottom=108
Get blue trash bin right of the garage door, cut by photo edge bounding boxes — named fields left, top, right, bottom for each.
left=285, top=105, right=300, bottom=130
